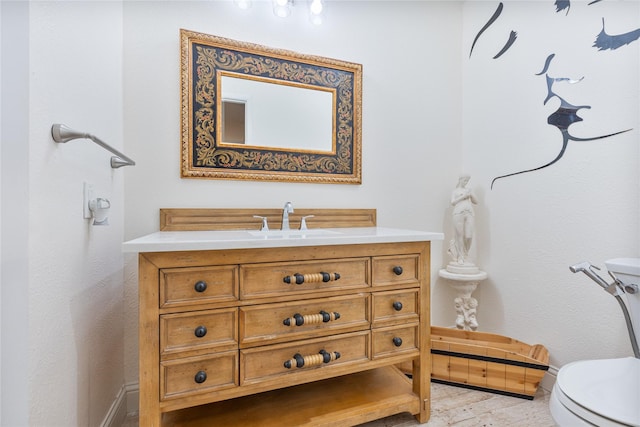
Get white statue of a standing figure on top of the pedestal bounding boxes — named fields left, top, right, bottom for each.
left=449, top=175, right=478, bottom=265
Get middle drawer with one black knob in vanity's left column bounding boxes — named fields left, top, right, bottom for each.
left=160, top=308, right=238, bottom=357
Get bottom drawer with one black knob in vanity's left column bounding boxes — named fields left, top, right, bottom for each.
left=160, top=351, right=238, bottom=400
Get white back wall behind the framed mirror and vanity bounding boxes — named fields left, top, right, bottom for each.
left=124, top=1, right=461, bottom=382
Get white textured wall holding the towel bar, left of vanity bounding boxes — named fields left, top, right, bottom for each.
left=25, top=2, right=126, bottom=426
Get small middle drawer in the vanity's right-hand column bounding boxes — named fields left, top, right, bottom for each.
left=372, top=288, right=419, bottom=326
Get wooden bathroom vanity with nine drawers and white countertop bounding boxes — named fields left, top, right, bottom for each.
left=124, top=210, right=442, bottom=426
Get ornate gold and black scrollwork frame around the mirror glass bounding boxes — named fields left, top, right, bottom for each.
left=180, top=30, right=362, bottom=184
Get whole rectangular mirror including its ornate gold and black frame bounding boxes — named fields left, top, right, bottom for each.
left=181, top=30, right=362, bottom=184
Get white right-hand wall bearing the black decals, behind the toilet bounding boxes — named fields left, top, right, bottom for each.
left=462, top=1, right=640, bottom=366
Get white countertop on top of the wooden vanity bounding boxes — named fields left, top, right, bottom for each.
left=122, top=227, right=444, bottom=253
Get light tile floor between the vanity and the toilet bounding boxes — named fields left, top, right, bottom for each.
left=122, top=383, right=555, bottom=427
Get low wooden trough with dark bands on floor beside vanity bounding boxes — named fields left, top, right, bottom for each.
left=431, top=326, right=549, bottom=400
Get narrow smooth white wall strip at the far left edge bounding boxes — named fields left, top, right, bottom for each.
left=0, top=2, right=29, bottom=426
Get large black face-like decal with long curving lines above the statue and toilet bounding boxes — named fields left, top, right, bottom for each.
left=491, top=54, right=631, bottom=189
